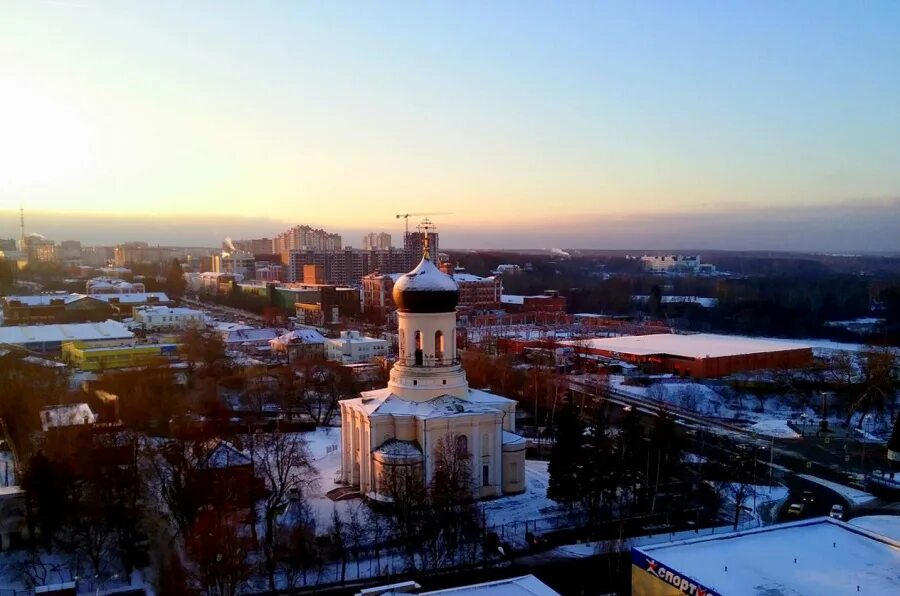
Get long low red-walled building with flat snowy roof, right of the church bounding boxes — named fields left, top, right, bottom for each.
left=560, top=333, right=813, bottom=378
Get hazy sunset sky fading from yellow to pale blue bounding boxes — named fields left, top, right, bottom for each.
left=0, top=0, right=900, bottom=250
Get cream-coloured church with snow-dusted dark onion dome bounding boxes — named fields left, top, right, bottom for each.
left=340, top=242, right=525, bottom=500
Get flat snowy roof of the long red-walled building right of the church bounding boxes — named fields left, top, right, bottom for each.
left=561, top=333, right=811, bottom=358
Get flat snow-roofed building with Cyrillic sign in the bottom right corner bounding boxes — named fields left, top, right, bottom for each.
left=631, top=518, right=900, bottom=596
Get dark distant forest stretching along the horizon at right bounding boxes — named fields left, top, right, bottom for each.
left=449, top=251, right=900, bottom=345
